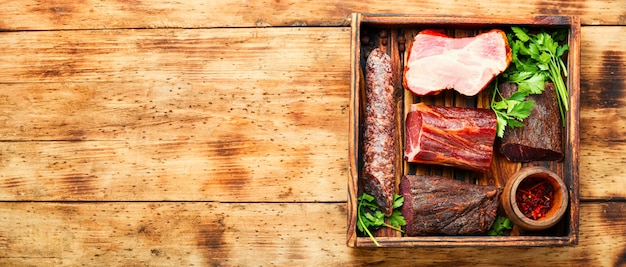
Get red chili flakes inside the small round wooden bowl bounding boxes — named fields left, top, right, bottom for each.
left=515, top=177, right=554, bottom=220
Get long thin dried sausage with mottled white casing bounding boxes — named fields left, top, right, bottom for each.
left=363, top=48, right=396, bottom=215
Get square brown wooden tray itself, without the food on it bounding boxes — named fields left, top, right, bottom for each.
left=347, top=14, right=580, bottom=247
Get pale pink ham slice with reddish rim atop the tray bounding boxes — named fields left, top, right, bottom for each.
left=404, top=29, right=511, bottom=96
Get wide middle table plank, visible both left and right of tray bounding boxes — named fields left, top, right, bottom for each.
left=0, top=27, right=626, bottom=201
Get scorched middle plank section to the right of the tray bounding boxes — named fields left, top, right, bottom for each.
left=580, top=27, right=626, bottom=199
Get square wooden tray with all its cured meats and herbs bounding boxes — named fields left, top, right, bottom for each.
left=347, top=14, right=580, bottom=248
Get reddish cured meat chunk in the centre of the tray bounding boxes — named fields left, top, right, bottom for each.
left=404, top=103, right=497, bottom=172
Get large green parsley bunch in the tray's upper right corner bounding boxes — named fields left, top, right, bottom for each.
left=491, top=26, right=569, bottom=137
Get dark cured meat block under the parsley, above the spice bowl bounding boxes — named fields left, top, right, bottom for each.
left=498, top=83, right=563, bottom=162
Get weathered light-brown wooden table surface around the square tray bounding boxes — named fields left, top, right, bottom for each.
left=0, top=0, right=626, bottom=266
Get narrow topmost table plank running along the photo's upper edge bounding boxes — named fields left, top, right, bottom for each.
left=0, top=0, right=626, bottom=30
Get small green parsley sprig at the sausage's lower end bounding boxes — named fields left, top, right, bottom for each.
left=357, top=193, right=406, bottom=246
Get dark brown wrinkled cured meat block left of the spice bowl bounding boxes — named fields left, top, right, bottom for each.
left=400, top=175, right=502, bottom=236
